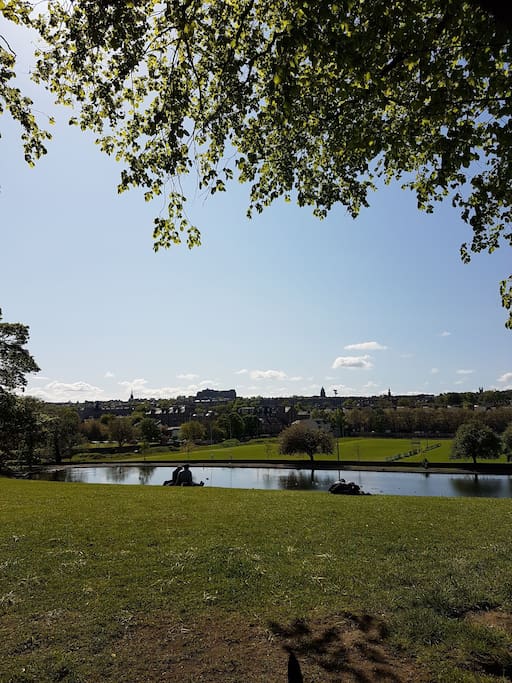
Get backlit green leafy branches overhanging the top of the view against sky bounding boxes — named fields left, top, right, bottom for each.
left=0, top=0, right=512, bottom=327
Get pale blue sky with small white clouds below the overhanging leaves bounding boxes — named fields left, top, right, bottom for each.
left=0, top=20, right=512, bottom=401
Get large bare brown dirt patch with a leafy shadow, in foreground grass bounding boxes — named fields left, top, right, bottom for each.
left=111, top=612, right=427, bottom=683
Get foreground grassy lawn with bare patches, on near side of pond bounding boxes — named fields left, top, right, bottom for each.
left=0, top=479, right=512, bottom=683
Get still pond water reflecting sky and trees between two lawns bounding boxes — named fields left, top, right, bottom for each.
left=38, top=465, right=512, bottom=498
